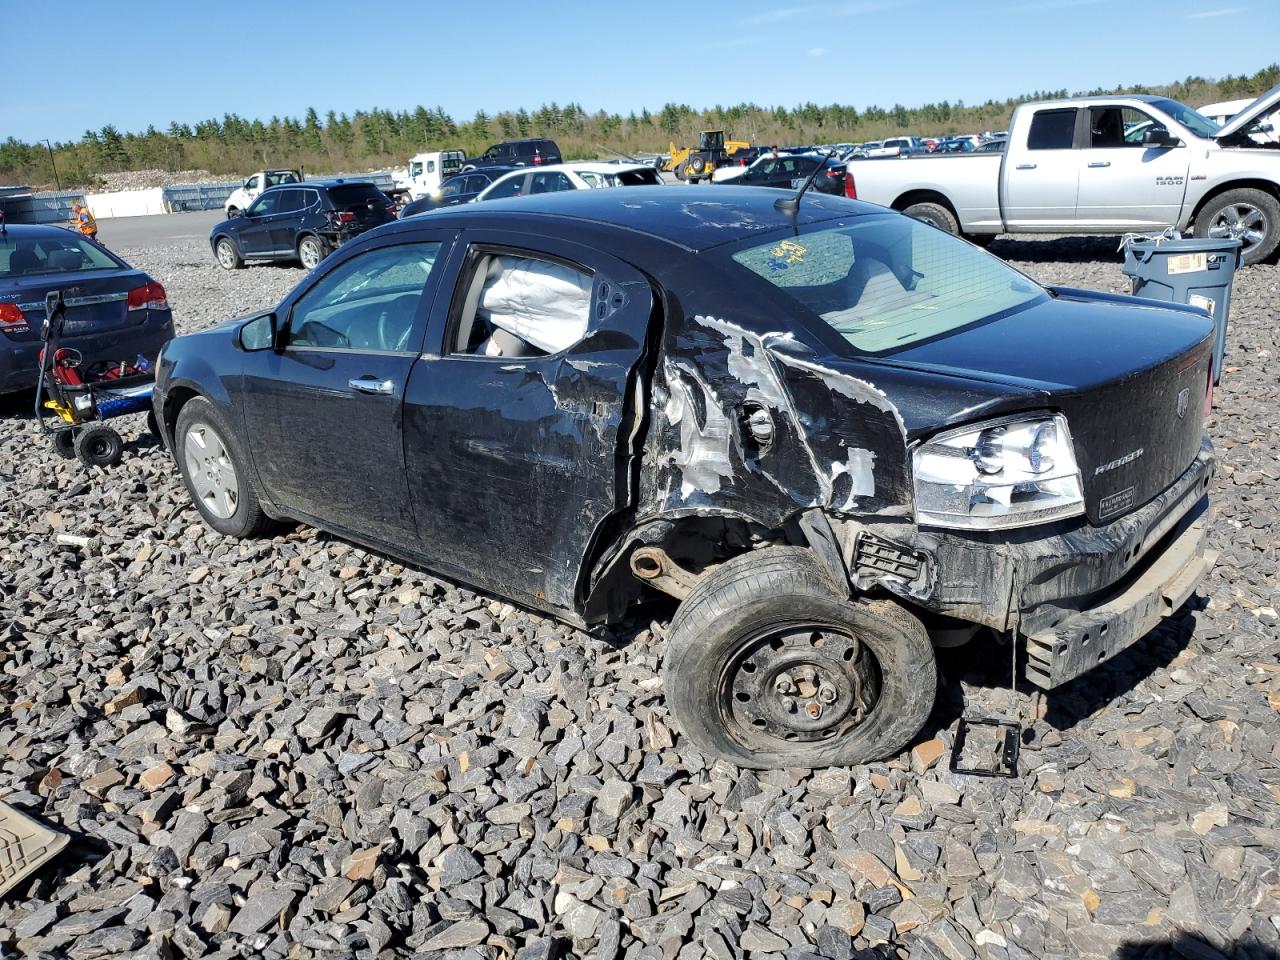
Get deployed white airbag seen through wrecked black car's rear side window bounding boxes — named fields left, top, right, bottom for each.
left=479, top=256, right=591, bottom=353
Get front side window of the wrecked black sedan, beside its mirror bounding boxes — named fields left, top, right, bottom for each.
left=285, top=243, right=440, bottom=352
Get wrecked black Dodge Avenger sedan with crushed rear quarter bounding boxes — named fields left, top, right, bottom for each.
left=155, top=187, right=1213, bottom=767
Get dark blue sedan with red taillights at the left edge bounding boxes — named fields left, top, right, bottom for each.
left=0, top=224, right=173, bottom=393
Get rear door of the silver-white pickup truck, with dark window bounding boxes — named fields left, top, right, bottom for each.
left=1001, top=106, right=1080, bottom=230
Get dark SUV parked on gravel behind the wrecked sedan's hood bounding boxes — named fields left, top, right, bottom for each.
left=209, top=180, right=396, bottom=270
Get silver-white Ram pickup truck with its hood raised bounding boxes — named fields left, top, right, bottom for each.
left=849, top=84, right=1280, bottom=264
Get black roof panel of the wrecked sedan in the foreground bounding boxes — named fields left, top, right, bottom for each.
left=397, top=184, right=886, bottom=251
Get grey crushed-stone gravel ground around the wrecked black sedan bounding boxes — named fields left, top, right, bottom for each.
left=0, top=232, right=1280, bottom=960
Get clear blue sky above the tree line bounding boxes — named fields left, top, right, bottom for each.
left=0, top=0, right=1280, bottom=141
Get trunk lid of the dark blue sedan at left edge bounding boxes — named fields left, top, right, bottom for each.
left=0, top=268, right=150, bottom=340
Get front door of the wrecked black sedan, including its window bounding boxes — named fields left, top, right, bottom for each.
left=243, top=230, right=452, bottom=549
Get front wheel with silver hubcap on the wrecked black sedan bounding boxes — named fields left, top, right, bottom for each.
left=173, top=397, right=271, bottom=538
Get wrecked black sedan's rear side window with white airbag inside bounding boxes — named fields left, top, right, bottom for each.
left=451, top=252, right=593, bottom=357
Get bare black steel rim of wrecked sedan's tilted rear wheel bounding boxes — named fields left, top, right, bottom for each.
left=718, top=623, right=881, bottom=750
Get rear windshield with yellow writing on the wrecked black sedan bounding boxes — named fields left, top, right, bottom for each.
left=731, top=216, right=1047, bottom=353
